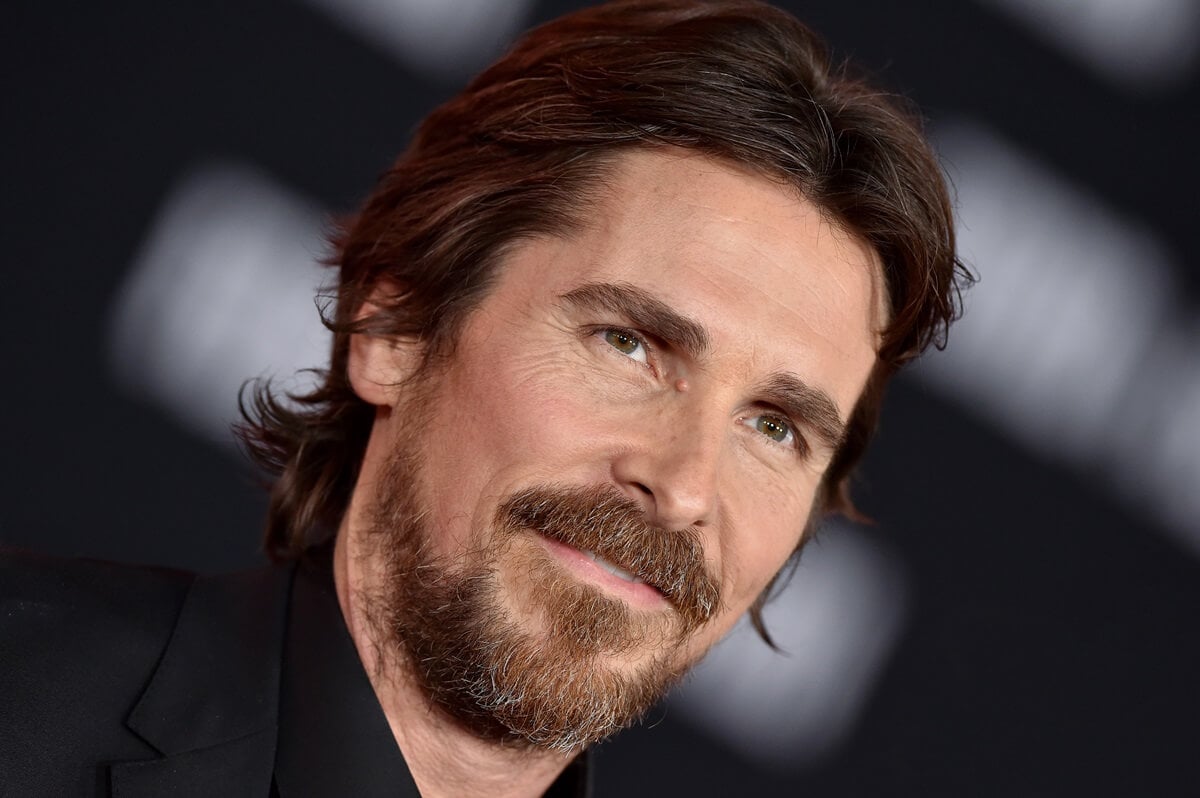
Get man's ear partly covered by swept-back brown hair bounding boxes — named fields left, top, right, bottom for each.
left=347, top=281, right=421, bottom=407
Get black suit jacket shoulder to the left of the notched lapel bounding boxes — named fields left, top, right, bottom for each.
left=0, top=552, right=196, bottom=794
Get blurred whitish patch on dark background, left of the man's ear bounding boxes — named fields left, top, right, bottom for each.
left=109, top=164, right=331, bottom=444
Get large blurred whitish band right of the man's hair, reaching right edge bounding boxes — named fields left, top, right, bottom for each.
left=914, top=124, right=1200, bottom=554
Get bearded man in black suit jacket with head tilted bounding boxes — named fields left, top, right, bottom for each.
left=0, top=0, right=959, bottom=797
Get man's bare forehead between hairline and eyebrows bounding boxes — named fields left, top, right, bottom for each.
left=510, top=149, right=883, bottom=416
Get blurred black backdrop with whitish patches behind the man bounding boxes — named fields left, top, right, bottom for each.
left=0, top=0, right=1200, bottom=797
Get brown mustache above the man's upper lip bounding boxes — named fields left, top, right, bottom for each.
left=497, top=486, right=721, bottom=632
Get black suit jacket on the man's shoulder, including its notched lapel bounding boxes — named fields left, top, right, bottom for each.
left=0, top=554, right=294, bottom=798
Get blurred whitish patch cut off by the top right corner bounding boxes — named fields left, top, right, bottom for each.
left=982, top=0, right=1200, bottom=90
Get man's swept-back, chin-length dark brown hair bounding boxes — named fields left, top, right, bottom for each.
left=240, top=0, right=968, bottom=630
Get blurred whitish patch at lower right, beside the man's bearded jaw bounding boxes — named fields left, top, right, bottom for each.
left=672, top=522, right=907, bottom=770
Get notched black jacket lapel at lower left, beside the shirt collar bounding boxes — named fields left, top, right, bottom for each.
left=110, top=568, right=293, bottom=798
